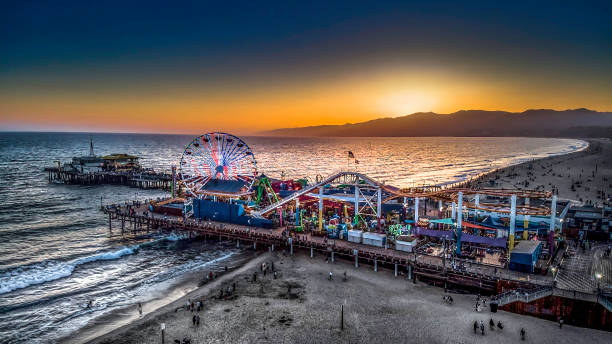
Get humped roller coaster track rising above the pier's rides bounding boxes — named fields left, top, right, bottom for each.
left=251, top=171, right=552, bottom=217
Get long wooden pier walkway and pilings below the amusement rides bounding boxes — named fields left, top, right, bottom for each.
left=101, top=202, right=612, bottom=331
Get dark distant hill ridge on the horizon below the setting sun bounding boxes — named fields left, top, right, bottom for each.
left=261, top=109, right=612, bottom=137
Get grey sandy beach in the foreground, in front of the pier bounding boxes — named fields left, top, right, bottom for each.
left=90, top=252, right=611, bottom=343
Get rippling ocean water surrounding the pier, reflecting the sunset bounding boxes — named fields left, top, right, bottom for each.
left=0, top=133, right=586, bottom=343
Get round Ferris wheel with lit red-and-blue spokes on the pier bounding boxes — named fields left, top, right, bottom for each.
left=180, top=132, right=257, bottom=196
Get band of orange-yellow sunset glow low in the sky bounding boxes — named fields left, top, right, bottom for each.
left=0, top=69, right=612, bottom=134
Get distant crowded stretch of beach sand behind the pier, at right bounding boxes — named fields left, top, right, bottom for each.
left=472, top=139, right=612, bottom=206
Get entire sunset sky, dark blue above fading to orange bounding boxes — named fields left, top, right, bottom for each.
left=0, top=0, right=612, bottom=134
